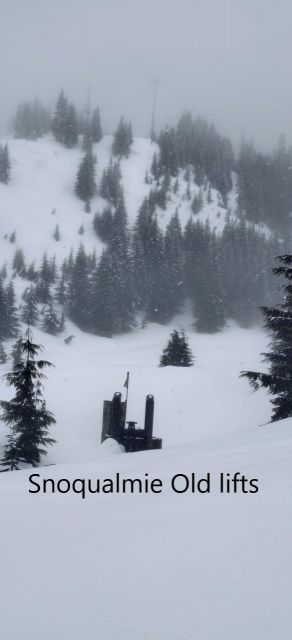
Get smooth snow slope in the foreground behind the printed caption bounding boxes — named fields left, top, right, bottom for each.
left=0, top=398, right=292, bottom=640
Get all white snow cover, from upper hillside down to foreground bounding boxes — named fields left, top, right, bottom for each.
left=0, top=137, right=292, bottom=640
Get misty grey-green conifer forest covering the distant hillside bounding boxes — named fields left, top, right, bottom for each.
left=0, top=91, right=292, bottom=348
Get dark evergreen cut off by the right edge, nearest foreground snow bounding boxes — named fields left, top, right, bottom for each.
left=241, top=255, right=292, bottom=422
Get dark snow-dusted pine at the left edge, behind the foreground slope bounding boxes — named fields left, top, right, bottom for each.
left=0, top=329, right=56, bottom=470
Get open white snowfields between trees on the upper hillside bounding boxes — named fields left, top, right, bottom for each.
left=0, top=136, right=242, bottom=266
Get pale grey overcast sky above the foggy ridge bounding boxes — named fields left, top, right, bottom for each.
left=0, top=0, right=292, bottom=148
